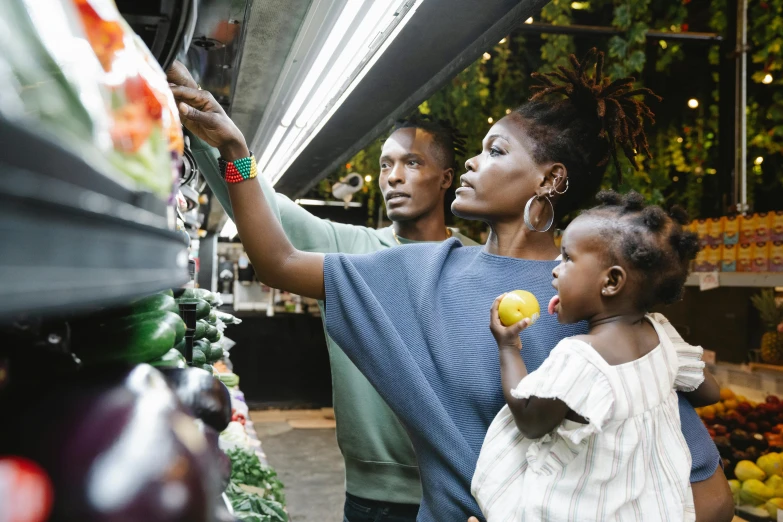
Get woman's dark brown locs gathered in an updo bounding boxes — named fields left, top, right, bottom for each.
left=515, top=48, right=661, bottom=216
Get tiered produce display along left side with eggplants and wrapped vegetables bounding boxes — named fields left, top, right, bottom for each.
left=0, top=0, right=287, bottom=522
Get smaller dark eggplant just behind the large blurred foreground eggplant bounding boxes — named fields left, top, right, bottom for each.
left=161, top=367, right=231, bottom=433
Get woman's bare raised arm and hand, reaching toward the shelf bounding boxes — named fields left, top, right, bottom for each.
left=171, top=86, right=325, bottom=299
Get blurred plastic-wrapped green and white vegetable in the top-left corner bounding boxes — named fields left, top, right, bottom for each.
left=0, top=0, right=111, bottom=167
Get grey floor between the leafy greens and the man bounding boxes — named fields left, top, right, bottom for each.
left=250, top=410, right=345, bottom=522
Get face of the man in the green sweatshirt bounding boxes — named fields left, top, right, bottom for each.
left=378, top=128, right=454, bottom=222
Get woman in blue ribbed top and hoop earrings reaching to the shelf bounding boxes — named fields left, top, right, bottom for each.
left=173, top=51, right=732, bottom=522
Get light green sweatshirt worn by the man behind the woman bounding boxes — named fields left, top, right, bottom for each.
left=190, top=135, right=476, bottom=504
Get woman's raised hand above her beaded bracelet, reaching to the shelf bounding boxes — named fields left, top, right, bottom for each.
left=167, top=70, right=250, bottom=161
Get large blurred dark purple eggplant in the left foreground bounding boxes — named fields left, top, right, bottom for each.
left=4, top=364, right=220, bottom=522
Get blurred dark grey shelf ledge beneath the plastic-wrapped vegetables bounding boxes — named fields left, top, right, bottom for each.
left=0, top=119, right=188, bottom=318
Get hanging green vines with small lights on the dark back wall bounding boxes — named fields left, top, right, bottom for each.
left=319, top=0, right=783, bottom=238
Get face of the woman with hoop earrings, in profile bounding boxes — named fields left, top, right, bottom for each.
left=451, top=113, right=546, bottom=223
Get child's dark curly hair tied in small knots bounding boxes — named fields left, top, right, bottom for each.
left=582, top=190, right=699, bottom=310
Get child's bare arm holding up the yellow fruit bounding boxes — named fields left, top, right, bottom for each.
left=489, top=294, right=569, bottom=439
